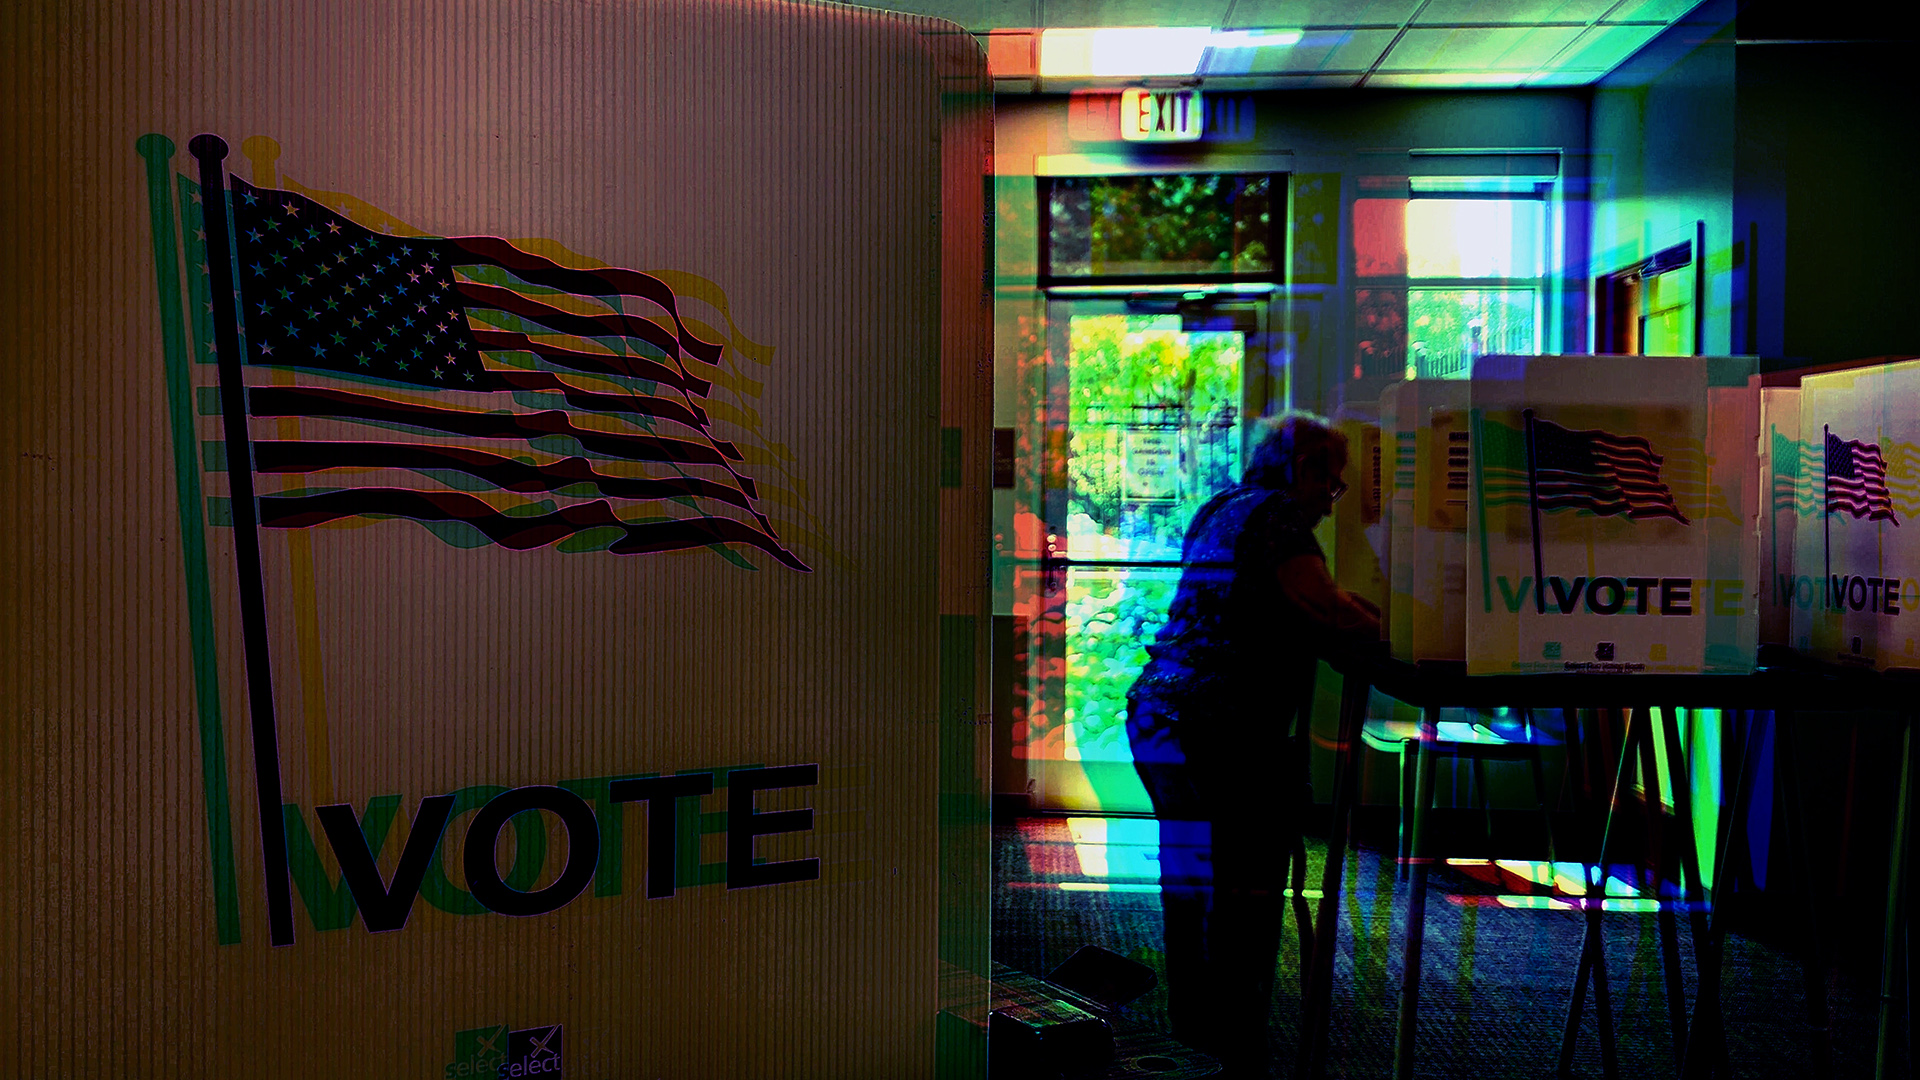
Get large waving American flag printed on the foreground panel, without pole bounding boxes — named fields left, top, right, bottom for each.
left=204, top=177, right=808, bottom=571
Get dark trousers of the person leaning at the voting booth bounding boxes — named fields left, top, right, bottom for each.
left=1135, top=691, right=1304, bottom=1076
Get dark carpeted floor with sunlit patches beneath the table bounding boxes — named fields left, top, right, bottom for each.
left=993, top=817, right=1910, bottom=1080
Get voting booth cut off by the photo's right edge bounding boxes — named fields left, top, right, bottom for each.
left=1791, top=361, right=1920, bottom=671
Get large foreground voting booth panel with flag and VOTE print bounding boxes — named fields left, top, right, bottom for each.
left=0, top=0, right=991, bottom=1080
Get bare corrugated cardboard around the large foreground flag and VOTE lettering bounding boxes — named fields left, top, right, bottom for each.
left=0, top=0, right=989, bottom=1078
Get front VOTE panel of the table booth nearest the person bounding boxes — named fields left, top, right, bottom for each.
left=1467, top=357, right=1759, bottom=673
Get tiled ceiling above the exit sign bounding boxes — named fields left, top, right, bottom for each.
left=864, top=0, right=1701, bottom=92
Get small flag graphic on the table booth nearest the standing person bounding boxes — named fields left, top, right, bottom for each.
left=1532, top=417, right=1688, bottom=525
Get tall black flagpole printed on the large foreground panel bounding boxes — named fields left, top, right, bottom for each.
left=186, top=135, right=294, bottom=945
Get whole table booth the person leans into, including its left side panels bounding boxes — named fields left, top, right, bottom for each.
left=1382, top=356, right=1759, bottom=675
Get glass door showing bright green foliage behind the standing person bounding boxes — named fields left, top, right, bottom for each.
left=1023, top=288, right=1286, bottom=813
